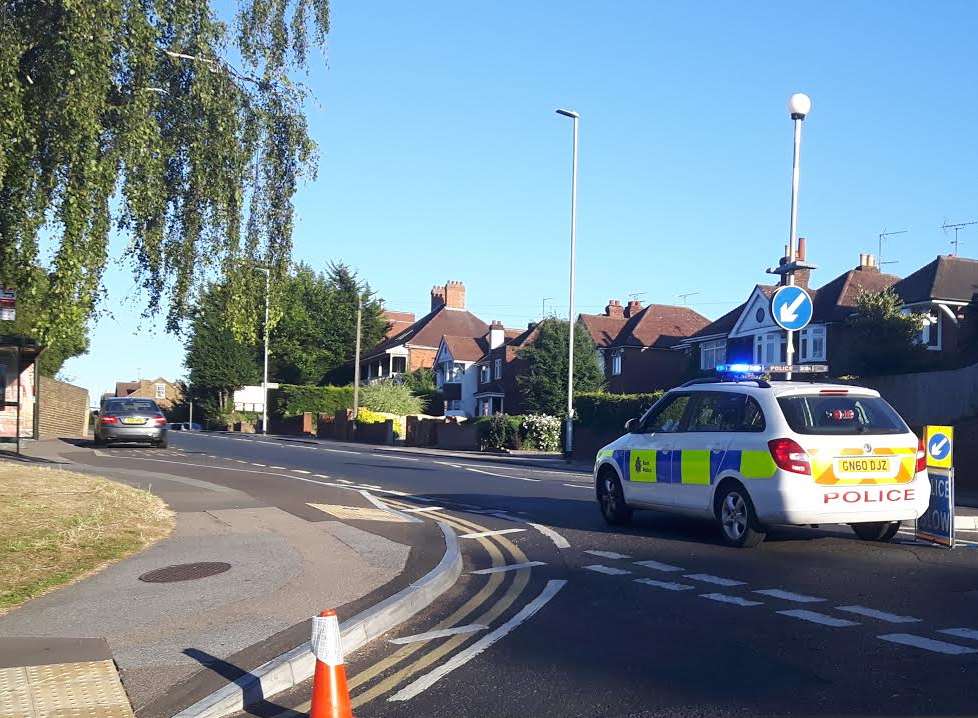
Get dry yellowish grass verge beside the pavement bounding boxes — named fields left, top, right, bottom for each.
left=0, top=462, right=173, bottom=615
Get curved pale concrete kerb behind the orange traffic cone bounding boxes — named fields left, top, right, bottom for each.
left=174, top=521, right=462, bottom=718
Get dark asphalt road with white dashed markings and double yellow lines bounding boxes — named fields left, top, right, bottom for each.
left=72, top=434, right=978, bottom=718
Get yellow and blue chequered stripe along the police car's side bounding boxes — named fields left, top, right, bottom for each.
left=598, top=449, right=777, bottom=486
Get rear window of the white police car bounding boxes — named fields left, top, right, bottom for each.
left=778, top=395, right=909, bottom=435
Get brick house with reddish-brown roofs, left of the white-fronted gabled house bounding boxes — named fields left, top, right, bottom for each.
left=579, top=299, right=709, bottom=394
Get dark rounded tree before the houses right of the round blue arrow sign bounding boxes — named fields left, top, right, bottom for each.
left=847, top=289, right=926, bottom=375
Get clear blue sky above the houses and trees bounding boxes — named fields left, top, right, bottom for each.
left=64, top=0, right=978, bottom=400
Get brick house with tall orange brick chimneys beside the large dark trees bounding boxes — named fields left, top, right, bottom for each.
left=360, top=282, right=489, bottom=381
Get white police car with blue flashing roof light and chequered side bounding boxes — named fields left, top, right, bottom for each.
left=594, top=365, right=930, bottom=547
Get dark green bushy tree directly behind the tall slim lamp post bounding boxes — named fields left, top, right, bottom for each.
left=516, top=319, right=604, bottom=416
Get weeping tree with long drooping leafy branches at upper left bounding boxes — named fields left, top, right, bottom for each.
left=0, top=0, right=329, bottom=345
